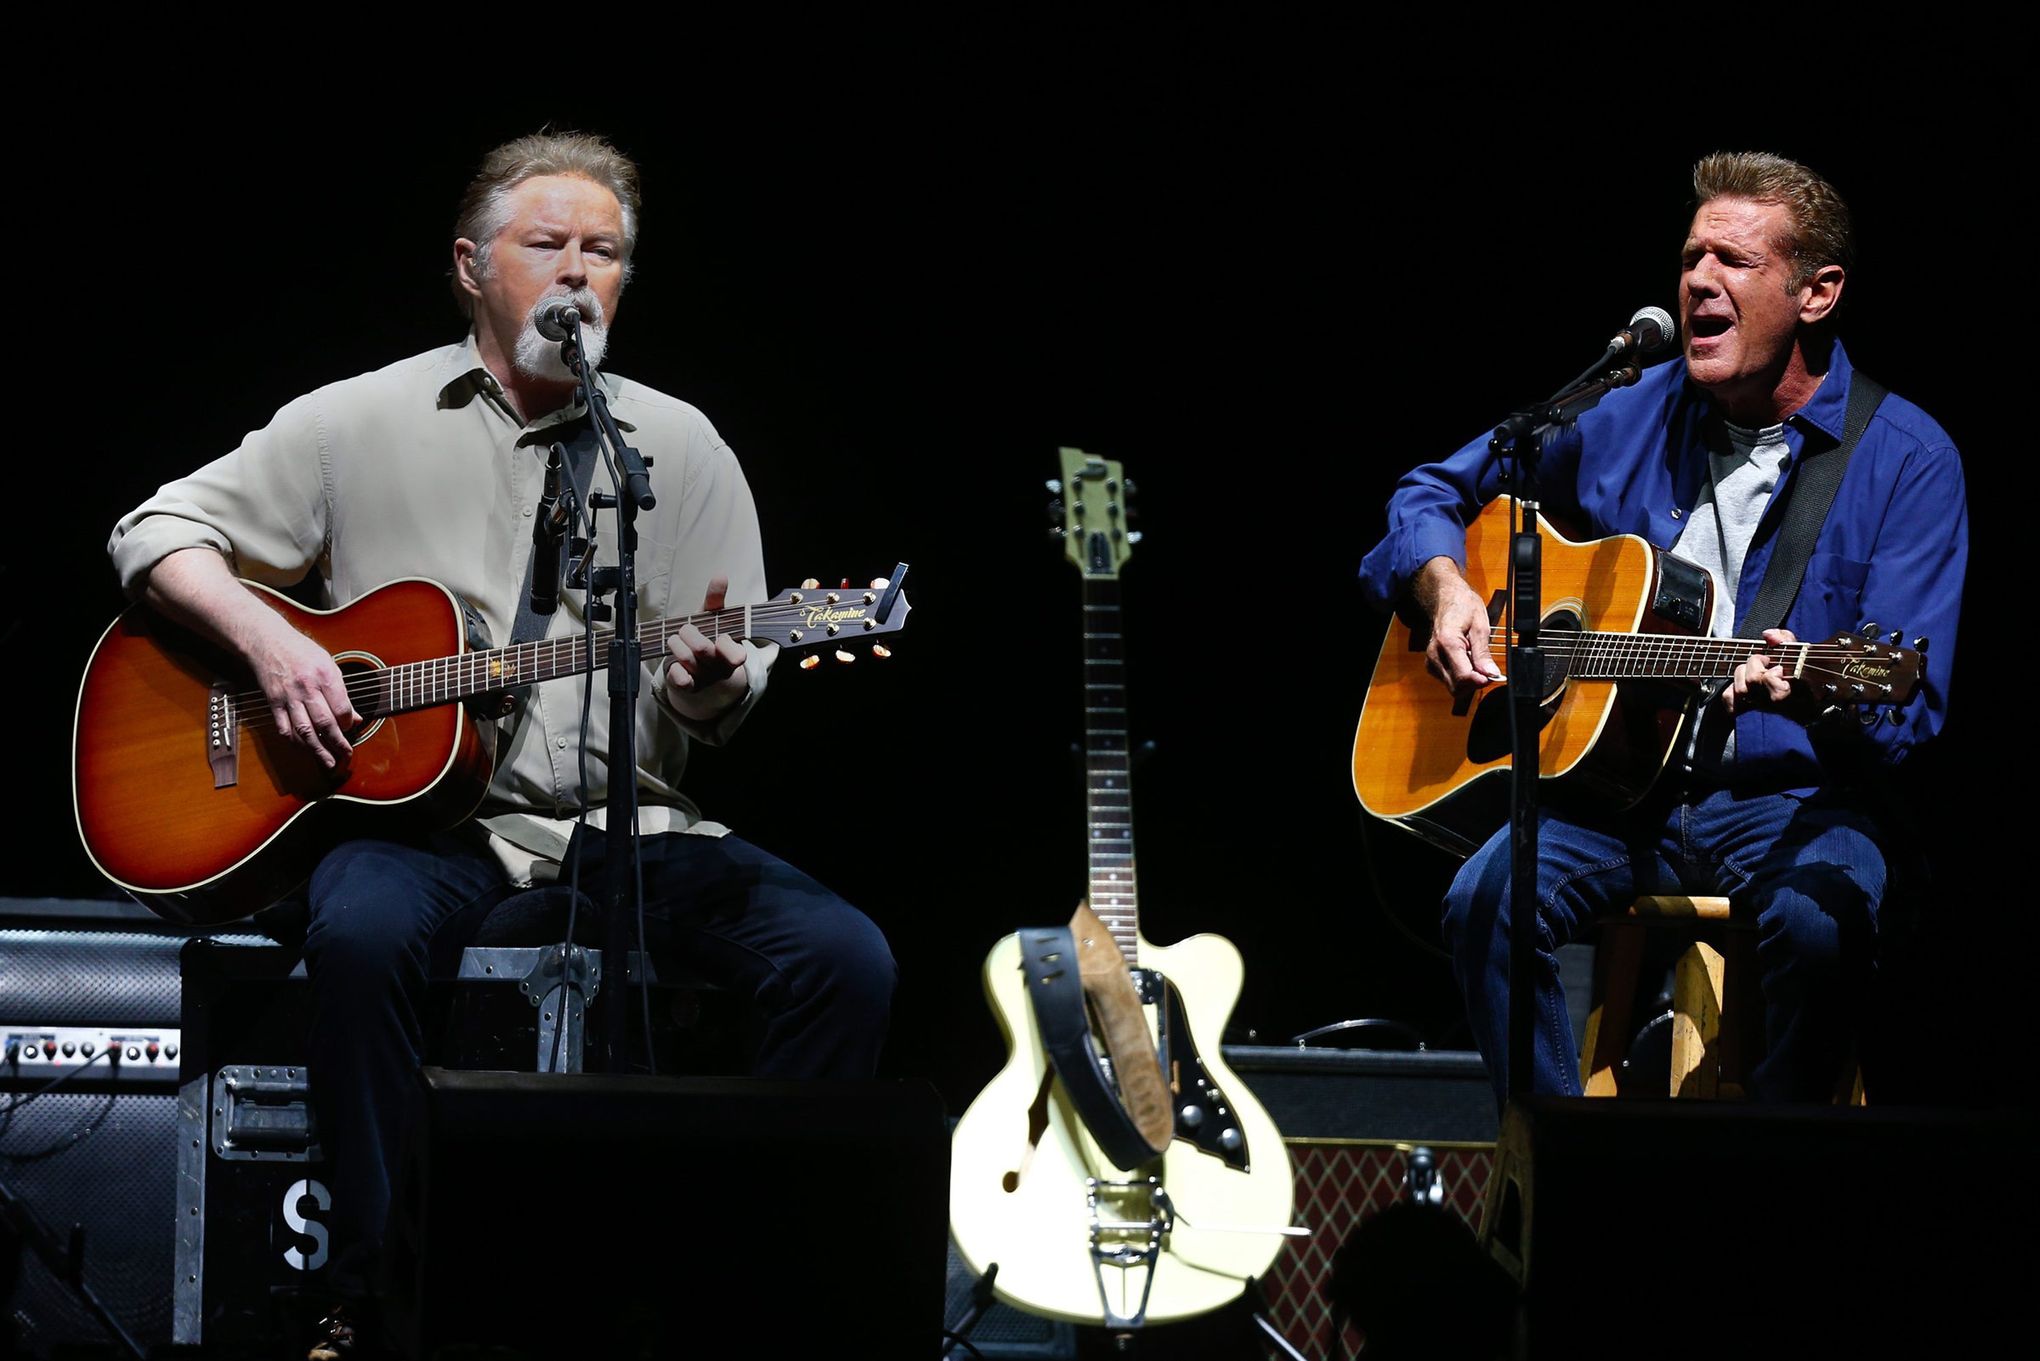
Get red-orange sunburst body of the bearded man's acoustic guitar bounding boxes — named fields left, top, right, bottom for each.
left=71, top=579, right=492, bottom=924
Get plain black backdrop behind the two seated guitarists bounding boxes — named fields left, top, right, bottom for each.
left=23, top=53, right=2034, bottom=1110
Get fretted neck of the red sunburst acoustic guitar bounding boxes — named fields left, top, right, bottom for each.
left=355, top=600, right=779, bottom=718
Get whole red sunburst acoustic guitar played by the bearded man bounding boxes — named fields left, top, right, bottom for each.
left=71, top=563, right=910, bottom=924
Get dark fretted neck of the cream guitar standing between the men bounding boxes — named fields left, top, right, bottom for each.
left=1083, top=575, right=1140, bottom=963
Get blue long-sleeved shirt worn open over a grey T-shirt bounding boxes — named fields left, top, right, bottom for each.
left=1361, top=341, right=1969, bottom=792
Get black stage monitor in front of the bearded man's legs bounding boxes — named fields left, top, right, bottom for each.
left=390, top=1067, right=949, bottom=1357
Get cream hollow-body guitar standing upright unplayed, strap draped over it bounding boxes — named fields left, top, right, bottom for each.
left=949, top=449, right=1308, bottom=1330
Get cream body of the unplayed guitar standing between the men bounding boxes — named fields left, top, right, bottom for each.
left=949, top=935, right=1293, bottom=1324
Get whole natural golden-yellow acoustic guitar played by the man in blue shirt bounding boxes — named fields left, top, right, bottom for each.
left=1353, top=498, right=1924, bottom=855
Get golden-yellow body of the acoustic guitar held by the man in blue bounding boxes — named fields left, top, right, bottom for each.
left=1353, top=500, right=1714, bottom=855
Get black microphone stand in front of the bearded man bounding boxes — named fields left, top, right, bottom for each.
left=559, top=308, right=657, bottom=1073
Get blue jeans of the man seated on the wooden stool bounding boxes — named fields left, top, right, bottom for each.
left=1444, top=790, right=1885, bottom=1102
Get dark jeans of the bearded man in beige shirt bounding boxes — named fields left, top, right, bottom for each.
left=304, top=833, right=896, bottom=1294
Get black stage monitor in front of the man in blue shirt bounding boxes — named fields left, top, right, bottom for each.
left=1485, top=1098, right=2040, bottom=1357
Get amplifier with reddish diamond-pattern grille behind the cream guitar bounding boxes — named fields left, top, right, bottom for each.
left=1224, top=1045, right=1499, bottom=1357
